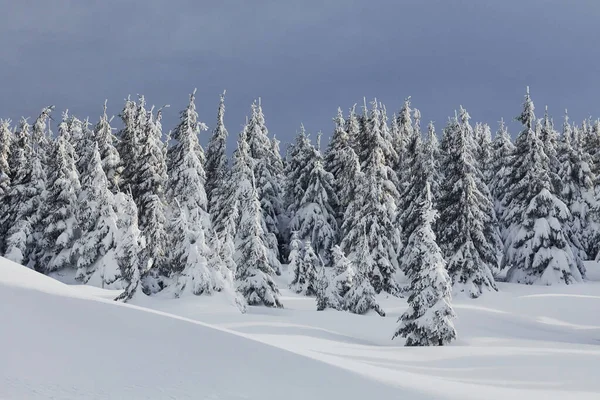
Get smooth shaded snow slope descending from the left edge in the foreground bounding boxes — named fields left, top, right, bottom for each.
left=0, top=259, right=412, bottom=400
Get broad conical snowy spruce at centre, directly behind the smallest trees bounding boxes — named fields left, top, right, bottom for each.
left=290, top=157, right=338, bottom=265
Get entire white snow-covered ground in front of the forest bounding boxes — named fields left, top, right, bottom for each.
left=0, top=259, right=600, bottom=400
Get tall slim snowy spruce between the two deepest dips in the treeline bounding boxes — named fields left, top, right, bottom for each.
left=246, top=99, right=283, bottom=268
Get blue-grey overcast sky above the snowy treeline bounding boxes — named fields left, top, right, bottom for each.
left=0, top=0, right=600, bottom=147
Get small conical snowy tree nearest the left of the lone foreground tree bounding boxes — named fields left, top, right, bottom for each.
left=345, top=232, right=385, bottom=317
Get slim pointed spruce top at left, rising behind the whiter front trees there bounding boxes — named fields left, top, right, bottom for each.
left=94, top=101, right=123, bottom=193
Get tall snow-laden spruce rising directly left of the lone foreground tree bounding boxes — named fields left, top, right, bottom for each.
left=341, top=102, right=400, bottom=295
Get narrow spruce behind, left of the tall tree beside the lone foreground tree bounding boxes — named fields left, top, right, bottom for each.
left=325, top=108, right=360, bottom=220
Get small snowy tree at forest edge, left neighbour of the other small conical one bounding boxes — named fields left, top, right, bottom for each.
left=317, top=246, right=355, bottom=311
